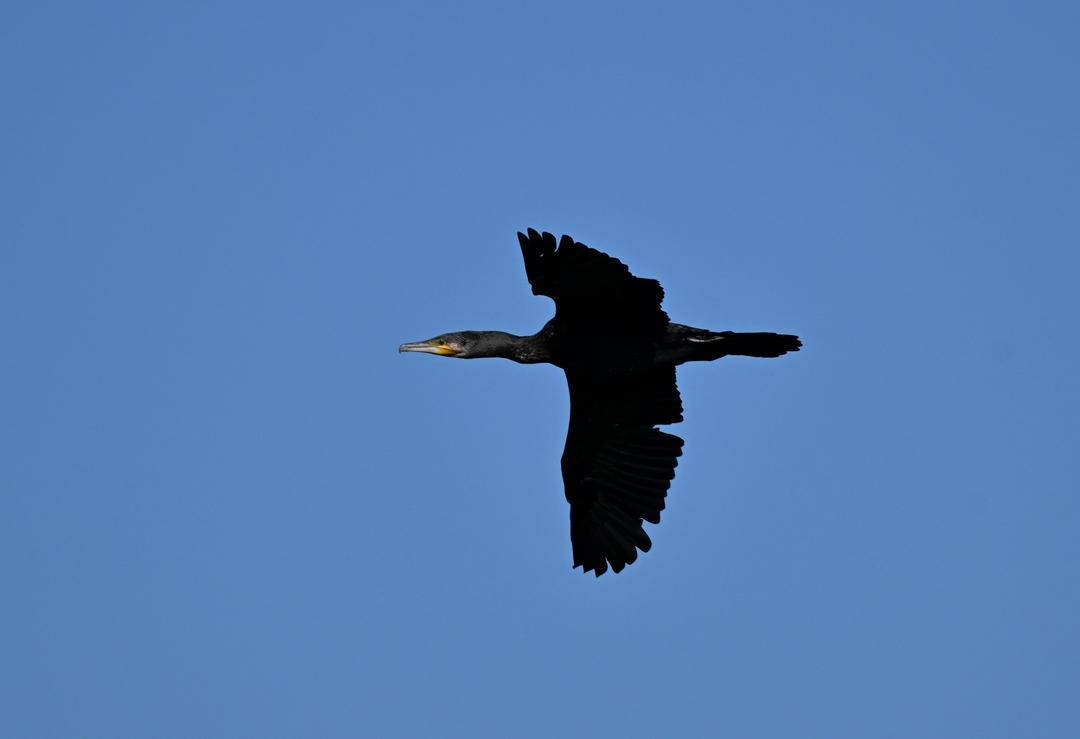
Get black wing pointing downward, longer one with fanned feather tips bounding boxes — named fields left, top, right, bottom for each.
left=563, top=365, right=683, bottom=577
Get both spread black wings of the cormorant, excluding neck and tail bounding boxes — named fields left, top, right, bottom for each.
left=517, top=228, right=683, bottom=577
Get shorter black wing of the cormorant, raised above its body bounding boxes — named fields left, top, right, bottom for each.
left=517, top=228, right=667, bottom=359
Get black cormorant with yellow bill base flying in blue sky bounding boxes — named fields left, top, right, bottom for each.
left=399, top=228, right=802, bottom=577
